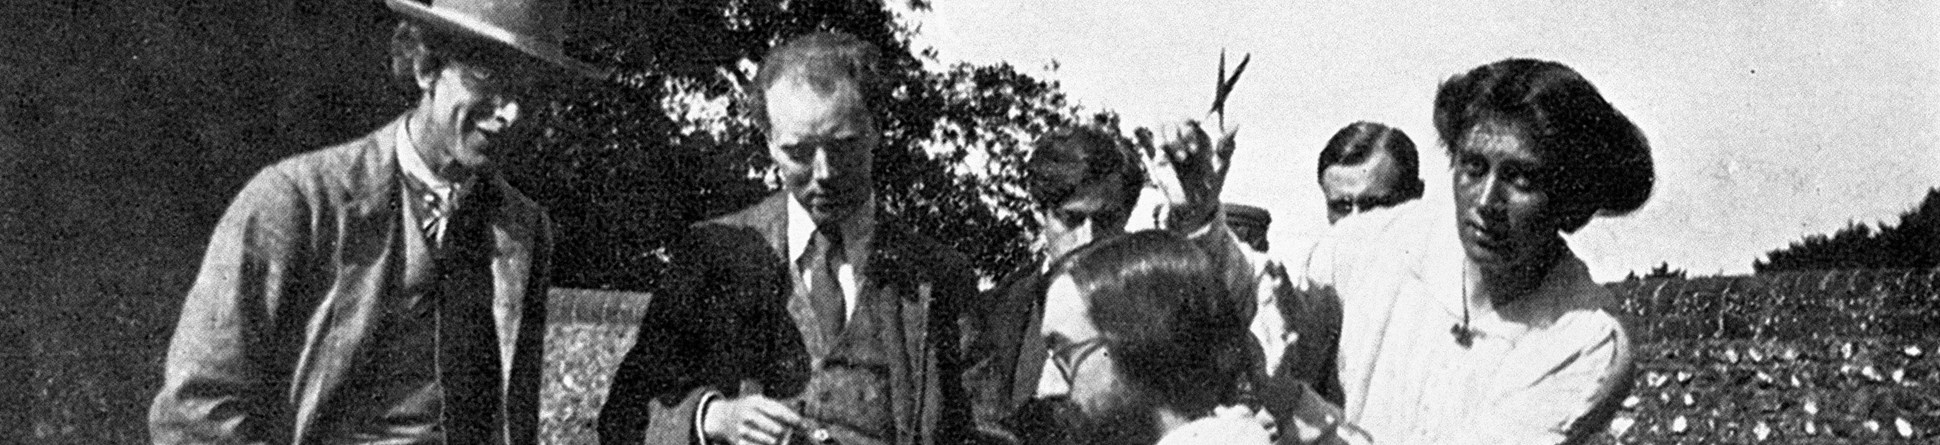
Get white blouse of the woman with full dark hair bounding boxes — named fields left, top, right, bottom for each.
left=1290, top=200, right=1632, bottom=443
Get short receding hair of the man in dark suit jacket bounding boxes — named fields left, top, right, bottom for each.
left=749, top=33, right=887, bottom=130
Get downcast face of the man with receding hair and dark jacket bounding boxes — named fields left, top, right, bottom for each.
left=764, top=76, right=879, bottom=225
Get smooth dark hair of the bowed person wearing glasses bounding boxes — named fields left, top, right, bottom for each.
left=1053, top=229, right=1251, bottom=414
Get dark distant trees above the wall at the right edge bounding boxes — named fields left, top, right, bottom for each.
left=1752, top=188, right=1940, bottom=274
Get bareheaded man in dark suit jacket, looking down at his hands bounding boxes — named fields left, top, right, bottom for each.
left=599, top=33, right=976, bottom=445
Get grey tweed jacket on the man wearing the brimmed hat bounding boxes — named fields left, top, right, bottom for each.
left=149, top=117, right=551, bottom=443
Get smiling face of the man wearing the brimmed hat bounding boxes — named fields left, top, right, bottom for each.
left=411, top=60, right=535, bottom=169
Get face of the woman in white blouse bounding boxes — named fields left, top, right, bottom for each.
left=1451, top=122, right=1562, bottom=274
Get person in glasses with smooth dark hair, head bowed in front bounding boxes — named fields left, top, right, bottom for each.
left=1040, top=231, right=1269, bottom=445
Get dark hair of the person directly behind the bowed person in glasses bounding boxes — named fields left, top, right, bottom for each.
left=1024, top=126, right=1145, bottom=225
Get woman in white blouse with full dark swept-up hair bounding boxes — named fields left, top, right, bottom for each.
left=1306, top=58, right=1655, bottom=443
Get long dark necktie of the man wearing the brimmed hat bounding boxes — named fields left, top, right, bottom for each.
left=425, top=178, right=504, bottom=443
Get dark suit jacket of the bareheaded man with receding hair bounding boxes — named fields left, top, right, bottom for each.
left=599, top=192, right=976, bottom=445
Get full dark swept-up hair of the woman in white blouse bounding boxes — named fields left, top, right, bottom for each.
left=1436, top=58, right=1657, bottom=233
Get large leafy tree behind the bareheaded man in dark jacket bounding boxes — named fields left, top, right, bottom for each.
left=508, top=0, right=1116, bottom=290
